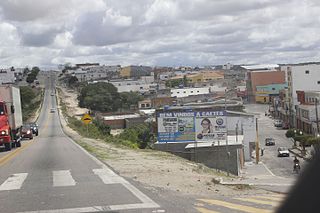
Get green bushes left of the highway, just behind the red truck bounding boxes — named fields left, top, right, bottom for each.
left=20, top=86, right=44, bottom=122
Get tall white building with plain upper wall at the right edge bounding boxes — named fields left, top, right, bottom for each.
left=280, top=63, right=320, bottom=126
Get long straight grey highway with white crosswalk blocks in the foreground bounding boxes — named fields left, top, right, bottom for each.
left=0, top=73, right=192, bottom=213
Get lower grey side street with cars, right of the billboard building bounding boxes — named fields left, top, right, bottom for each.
left=245, top=104, right=305, bottom=177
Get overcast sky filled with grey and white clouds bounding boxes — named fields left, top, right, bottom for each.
left=0, top=0, right=320, bottom=67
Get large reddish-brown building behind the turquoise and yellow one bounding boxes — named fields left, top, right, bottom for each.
left=246, top=70, right=286, bottom=103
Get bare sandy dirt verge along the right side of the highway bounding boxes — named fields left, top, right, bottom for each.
left=59, top=88, right=266, bottom=197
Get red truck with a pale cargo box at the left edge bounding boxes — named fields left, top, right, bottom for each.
left=0, top=84, right=22, bottom=151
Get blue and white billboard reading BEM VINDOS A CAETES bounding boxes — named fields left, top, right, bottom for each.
left=157, top=111, right=226, bottom=142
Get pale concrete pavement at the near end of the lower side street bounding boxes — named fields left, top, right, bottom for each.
left=220, top=162, right=295, bottom=193
